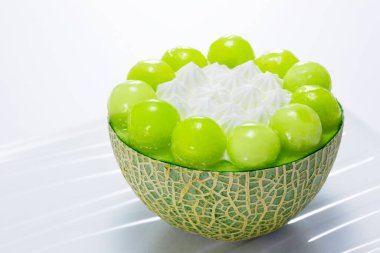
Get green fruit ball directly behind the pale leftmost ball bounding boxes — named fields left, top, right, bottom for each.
left=127, top=60, right=175, bottom=90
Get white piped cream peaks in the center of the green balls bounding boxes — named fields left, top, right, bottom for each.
left=157, top=61, right=291, bottom=133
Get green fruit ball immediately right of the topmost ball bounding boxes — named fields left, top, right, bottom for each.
left=255, top=49, right=299, bottom=78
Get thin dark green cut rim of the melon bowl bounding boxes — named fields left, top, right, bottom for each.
left=107, top=102, right=344, bottom=173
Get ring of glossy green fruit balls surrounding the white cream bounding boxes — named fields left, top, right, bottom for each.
left=108, top=35, right=342, bottom=171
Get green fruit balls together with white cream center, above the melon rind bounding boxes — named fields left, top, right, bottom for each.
left=108, top=35, right=342, bottom=171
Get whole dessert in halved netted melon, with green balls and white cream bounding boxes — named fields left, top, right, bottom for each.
left=108, top=35, right=343, bottom=241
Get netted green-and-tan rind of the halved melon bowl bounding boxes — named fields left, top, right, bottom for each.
left=109, top=126, right=343, bottom=241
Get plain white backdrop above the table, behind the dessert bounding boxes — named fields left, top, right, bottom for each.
left=0, top=0, right=380, bottom=144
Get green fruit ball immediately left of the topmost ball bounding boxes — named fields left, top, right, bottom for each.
left=162, top=47, right=207, bottom=71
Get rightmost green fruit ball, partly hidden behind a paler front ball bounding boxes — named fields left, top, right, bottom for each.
left=291, top=85, right=342, bottom=132
